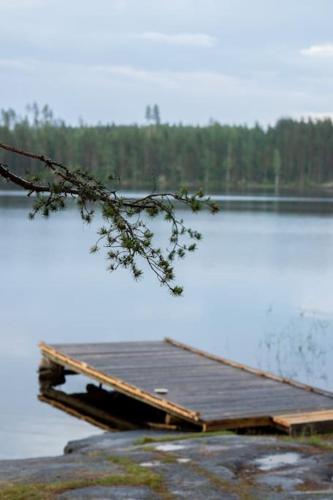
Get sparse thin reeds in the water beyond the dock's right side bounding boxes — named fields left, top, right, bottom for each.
left=258, top=306, right=332, bottom=384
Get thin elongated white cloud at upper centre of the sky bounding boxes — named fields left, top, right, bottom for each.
left=132, top=31, right=217, bottom=47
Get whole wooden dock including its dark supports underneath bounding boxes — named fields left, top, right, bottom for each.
left=40, top=339, right=333, bottom=434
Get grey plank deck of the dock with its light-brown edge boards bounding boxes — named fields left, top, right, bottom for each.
left=40, top=339, right=333, bottom=432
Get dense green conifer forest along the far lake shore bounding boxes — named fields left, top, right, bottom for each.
left=0, top=104, right=333, bottom=192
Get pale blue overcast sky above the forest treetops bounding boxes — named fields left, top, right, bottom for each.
left=0, top=0, right=333, bottom=124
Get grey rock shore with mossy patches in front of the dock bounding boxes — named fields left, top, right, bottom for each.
left=0, top=430, right=333, bottom=500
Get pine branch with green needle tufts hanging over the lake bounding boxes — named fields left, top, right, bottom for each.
left=0, top=143, right=218, bottom=295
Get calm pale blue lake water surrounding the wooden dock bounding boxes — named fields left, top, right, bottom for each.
left=0, top=192, right=333, bottom=458
